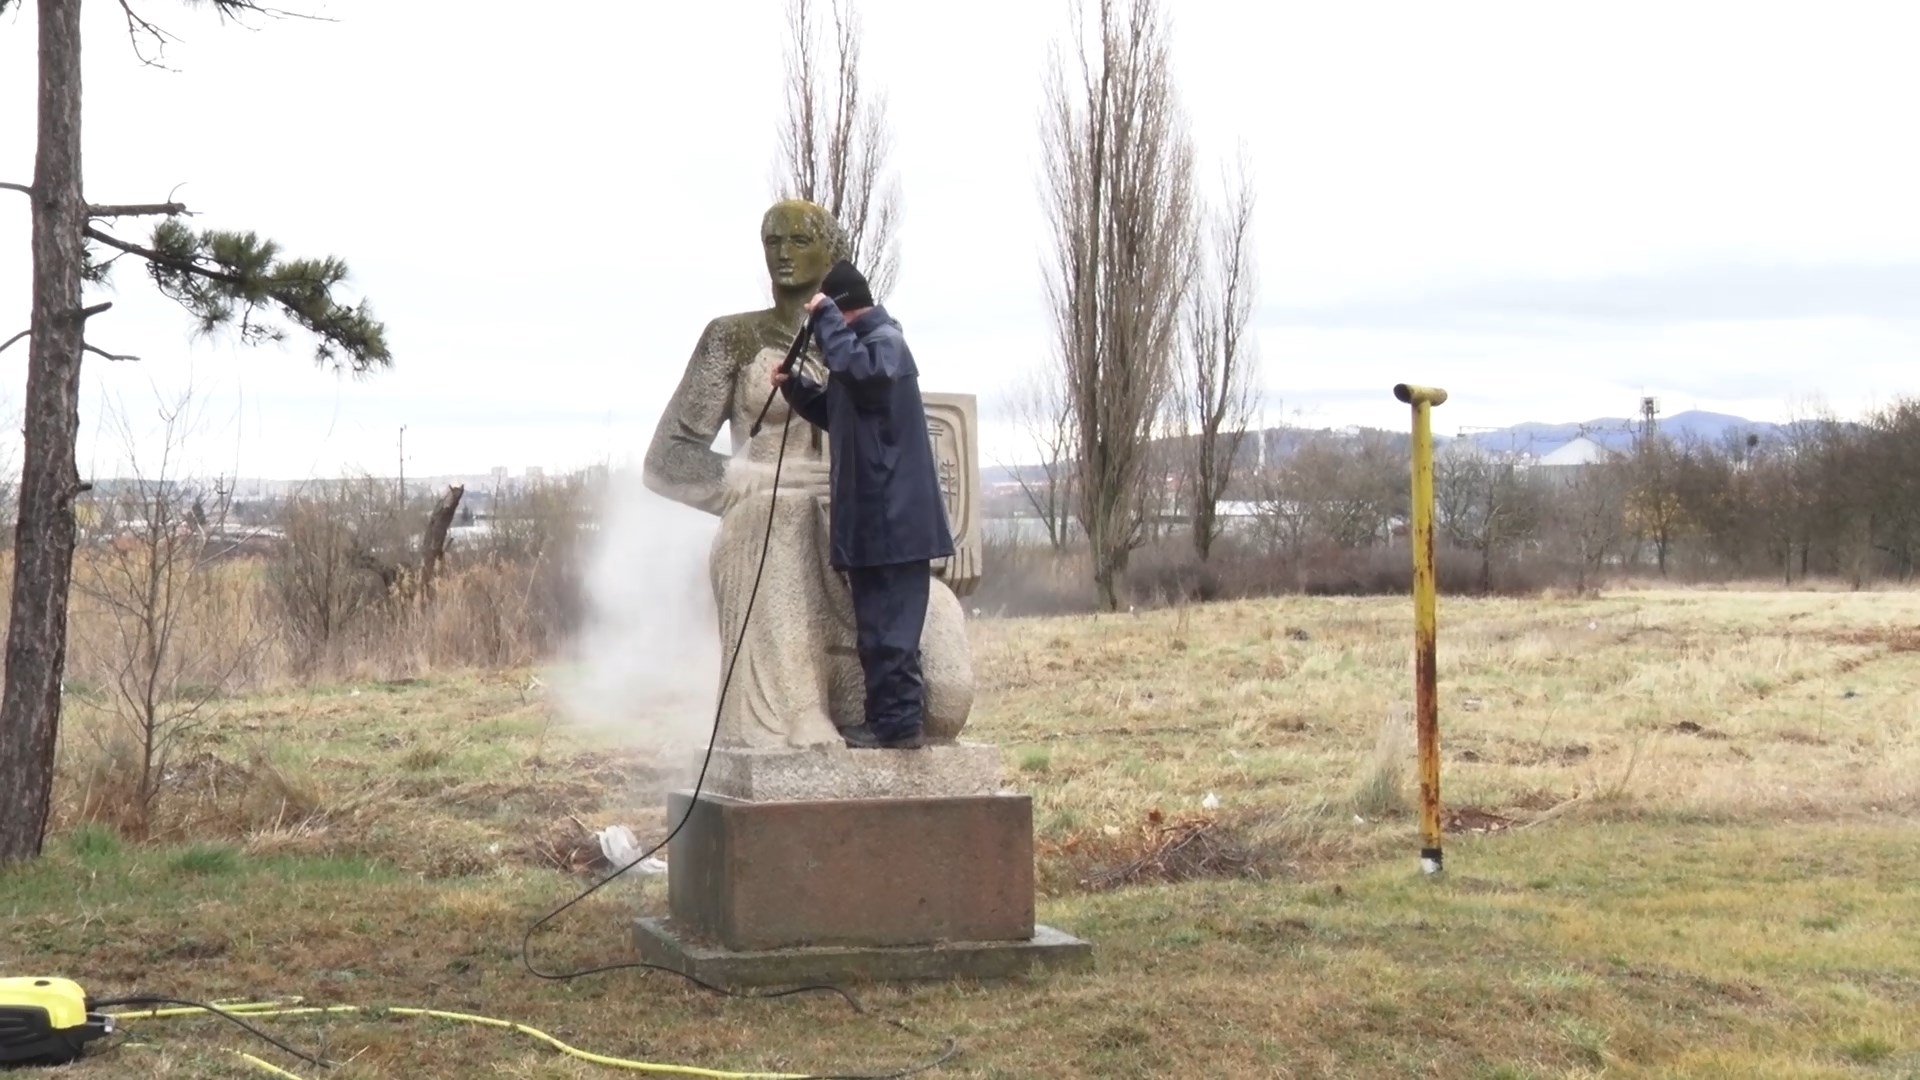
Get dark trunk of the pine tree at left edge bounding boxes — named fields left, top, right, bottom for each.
left=0, top=0, right=86, bottom=863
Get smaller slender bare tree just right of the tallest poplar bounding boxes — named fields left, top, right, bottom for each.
left=1173, top=152, right=1260, bottom=561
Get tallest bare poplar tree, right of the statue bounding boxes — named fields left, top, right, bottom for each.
left=1041, top=0, right=1194, bottom=611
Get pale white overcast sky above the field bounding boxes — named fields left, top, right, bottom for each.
left=0, top=0, right=1920, bottom=479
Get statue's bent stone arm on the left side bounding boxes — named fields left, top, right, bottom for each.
left=641, top=319, right=733, bottom=513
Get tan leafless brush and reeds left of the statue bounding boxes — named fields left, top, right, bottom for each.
left=24, top=394, right=607, bottom=711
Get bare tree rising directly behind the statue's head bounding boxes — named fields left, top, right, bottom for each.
left=774, top=0, right=900, bottom=302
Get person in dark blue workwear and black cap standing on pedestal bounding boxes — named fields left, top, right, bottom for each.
left=774, top=259, right=954, bottom=749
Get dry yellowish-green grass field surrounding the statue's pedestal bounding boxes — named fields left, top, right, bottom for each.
left=0, top=590, right=1920, bottom=1080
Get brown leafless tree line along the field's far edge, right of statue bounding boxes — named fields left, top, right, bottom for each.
left=987, top=400, right=1920, bottom=609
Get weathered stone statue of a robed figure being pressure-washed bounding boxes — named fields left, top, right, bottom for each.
left=645, top=200, right=973, bottom=748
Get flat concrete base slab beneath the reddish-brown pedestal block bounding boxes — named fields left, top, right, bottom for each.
left=634, top=919, right=1092, bottom=990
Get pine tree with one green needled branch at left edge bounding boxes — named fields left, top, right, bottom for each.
left=0, top=0, right=392, bottom=863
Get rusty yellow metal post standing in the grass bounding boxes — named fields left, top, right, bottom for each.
left=1394, top=382, right=1446, bottom=874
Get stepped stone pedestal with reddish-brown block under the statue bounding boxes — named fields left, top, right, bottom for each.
left=636, top=744, right=1092, bottom=986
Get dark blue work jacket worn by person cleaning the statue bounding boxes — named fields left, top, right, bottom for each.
left=780, top=300, right=954, bottom=571
